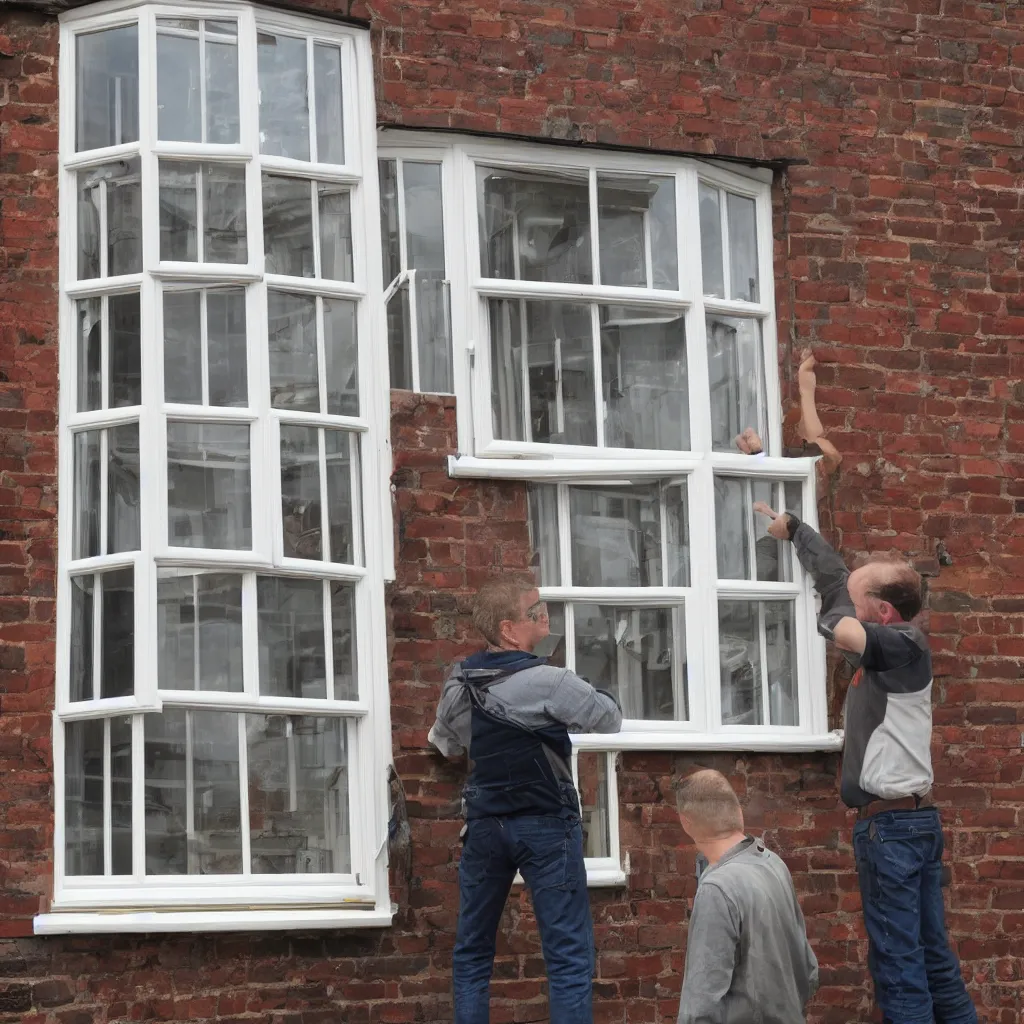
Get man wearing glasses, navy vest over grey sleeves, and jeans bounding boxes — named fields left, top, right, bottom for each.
left=429, top=577, right=623, bottom=1024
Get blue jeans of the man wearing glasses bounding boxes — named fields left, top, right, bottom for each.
left=453, top=810, right=594, bottom=1024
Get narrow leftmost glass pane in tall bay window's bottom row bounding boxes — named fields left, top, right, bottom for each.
left=63, top=719, right=103, bottom=876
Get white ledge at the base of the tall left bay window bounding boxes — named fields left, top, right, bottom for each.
left=33, top=904, right=398, bottom=935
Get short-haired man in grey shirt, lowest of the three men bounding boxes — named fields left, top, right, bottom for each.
left=678, top=769, right=818, bottom=1024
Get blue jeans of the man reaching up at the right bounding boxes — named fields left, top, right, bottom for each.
left=853, top=808, right=978, bottom=1024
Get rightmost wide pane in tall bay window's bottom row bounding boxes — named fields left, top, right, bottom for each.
left=246, top=715, right=351, bottom=874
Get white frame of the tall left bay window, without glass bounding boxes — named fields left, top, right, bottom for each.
left=41, top=0, right=393, bottom=934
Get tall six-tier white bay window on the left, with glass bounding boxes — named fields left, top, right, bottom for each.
left=43, top=0, right=391, bottom=932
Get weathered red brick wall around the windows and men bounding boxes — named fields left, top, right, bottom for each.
left=0, top=0, right=1024, bottom=1024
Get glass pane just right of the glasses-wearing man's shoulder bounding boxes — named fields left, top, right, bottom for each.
left=573, top=604, right=687, bottom=721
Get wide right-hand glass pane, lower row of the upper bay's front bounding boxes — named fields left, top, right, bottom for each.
left=600, top=306, right=690, bottom=452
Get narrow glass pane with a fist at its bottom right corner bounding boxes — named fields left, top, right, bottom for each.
left=707, top=313, right=768, bottom=452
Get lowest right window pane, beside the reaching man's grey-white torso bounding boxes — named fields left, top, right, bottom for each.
left=718, top=601, right=799, bottom=725
